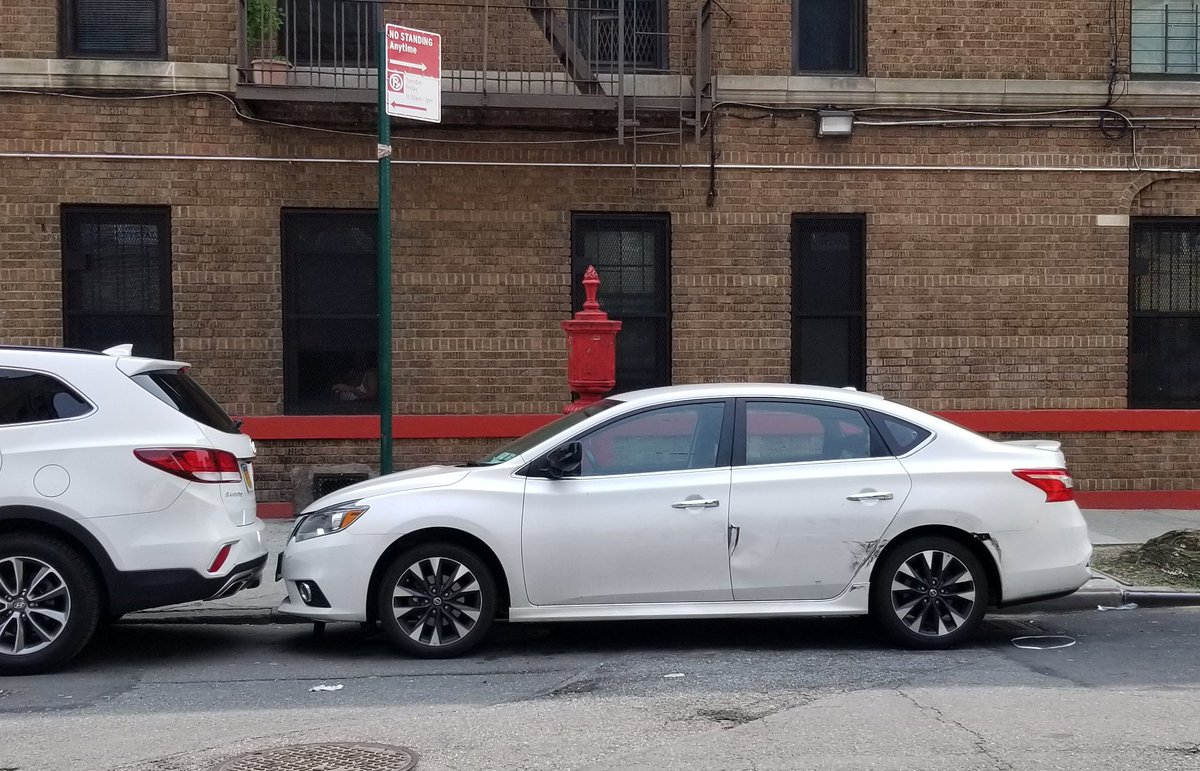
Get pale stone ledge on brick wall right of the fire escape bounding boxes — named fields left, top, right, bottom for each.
left=714, top=74, right=1200, bottom=108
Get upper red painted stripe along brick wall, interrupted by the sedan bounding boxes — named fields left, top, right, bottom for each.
left=242, top=410, right=1200, bottom=442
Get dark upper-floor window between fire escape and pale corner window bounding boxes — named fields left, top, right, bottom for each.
left=792, top=0, right=865, bottom=74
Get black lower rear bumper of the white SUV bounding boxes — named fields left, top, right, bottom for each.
left=109, top=554, right=266, bottom=616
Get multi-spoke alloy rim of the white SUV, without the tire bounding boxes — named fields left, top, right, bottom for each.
left=0, top=555, right=71, bottom=656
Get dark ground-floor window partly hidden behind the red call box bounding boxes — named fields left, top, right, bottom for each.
left=571, top=214, right=671, bottom=392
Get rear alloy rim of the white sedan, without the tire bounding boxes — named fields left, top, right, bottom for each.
left=892, top=549, right=976, bottom=636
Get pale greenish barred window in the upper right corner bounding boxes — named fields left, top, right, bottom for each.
left=1130, top=0, right=1200, bottom=76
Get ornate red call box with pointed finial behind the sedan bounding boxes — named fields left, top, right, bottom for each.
left=563, top=265, right=620, bottom=413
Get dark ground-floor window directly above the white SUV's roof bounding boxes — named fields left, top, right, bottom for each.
left=62, top=207, right=174, bottom=359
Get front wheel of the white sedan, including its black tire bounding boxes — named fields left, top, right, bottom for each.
left=376, top=543, right=497, bottom=658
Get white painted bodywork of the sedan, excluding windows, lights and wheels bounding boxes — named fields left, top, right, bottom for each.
left=280, top=384, right=1091, bottom=621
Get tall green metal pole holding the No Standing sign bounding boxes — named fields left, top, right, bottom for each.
left=376, top=19, right=391, bottom=476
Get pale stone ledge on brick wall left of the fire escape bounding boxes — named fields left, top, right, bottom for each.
left=0, top=59, right=236, bottom=92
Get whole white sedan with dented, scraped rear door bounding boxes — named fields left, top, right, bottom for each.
left=280, top=384, right=1092, bottom=657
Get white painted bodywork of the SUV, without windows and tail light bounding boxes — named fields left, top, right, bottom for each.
left=0, top=348, right=266, bottom=591
